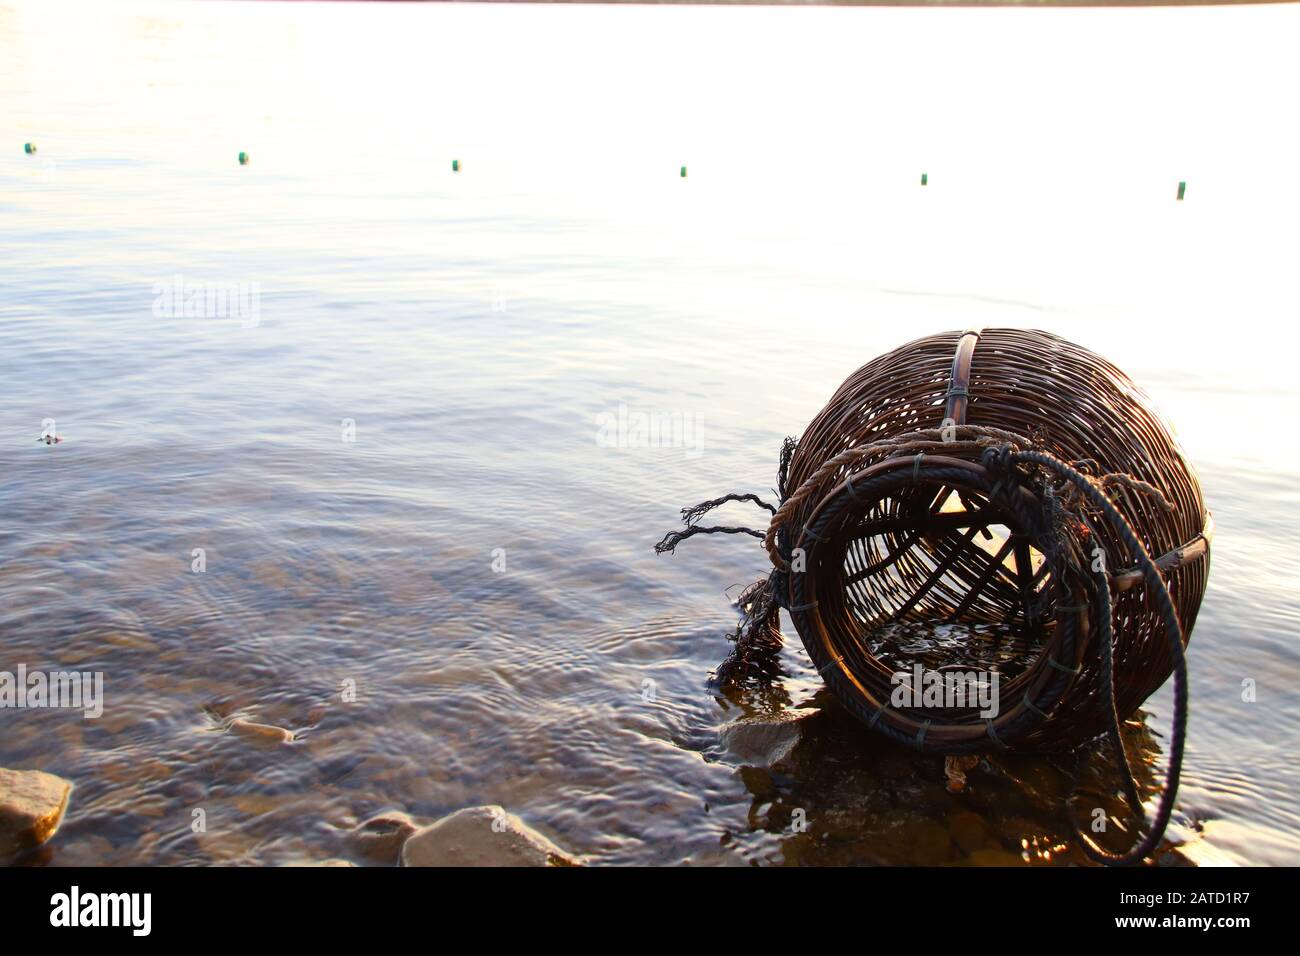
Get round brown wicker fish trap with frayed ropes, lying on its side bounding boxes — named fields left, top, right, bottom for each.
left=657, top=329, right=1213, bottom=868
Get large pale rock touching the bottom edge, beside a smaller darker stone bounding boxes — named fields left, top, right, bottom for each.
left=402, top=806, right=579, bottom=866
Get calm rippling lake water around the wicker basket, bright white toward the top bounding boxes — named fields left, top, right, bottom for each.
left=0, top=0, right=1300, bottom=865
